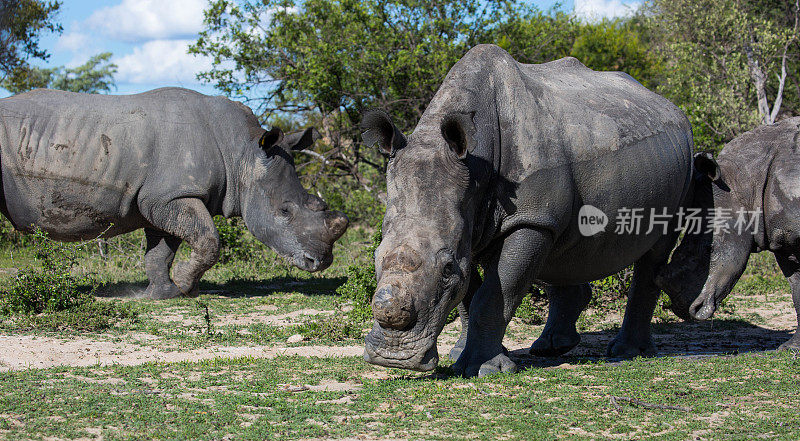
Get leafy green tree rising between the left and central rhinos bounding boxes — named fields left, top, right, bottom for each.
left=190, top=0, right=520, bottom=203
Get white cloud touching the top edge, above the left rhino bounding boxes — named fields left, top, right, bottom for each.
left=87, top=0, right=208, bottom=42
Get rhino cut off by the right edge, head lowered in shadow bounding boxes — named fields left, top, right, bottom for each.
left=656, top=117, right=800, bottom=349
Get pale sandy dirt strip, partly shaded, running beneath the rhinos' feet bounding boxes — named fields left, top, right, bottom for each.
left=0, top=294, right=797, bottom=371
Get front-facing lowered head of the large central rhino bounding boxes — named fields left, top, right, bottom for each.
left=362, top=111, right=484, bottom=371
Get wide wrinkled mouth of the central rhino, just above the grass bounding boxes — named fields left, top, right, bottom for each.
left=364, top=323, right=439, bottom=372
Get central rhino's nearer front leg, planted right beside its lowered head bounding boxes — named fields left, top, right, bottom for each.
left=453, top=228, right=553, bottom=377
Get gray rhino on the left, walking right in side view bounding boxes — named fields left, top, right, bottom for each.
left=0, top=88, right=347, bottom=298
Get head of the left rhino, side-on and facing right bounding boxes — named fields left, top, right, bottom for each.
left=240, top=128, right=348, bottom=272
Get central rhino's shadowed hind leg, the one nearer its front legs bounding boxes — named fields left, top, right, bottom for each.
left=530, top=283, right=592, bottom=357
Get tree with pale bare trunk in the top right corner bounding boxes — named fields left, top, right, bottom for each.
left=646, top=0, right=800, bottom=150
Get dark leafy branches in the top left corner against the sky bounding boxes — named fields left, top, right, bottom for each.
left=0, top=0, right=62, bottom=79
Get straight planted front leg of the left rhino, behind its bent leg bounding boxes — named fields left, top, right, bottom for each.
left=144, top=228, right=181, bottom=299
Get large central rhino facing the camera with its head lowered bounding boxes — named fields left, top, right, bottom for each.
left=362, top=45, right=692, bottom=376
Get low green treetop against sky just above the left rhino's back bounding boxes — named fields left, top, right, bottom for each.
left=0, top=52, right=117, bottom=93
